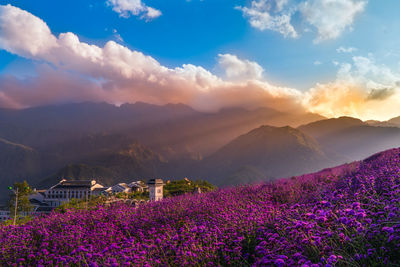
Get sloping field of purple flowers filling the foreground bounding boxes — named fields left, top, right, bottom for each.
left=0, top=149, right=400, bottom=266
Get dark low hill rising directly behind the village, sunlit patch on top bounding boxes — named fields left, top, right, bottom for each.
left=36, top=138, right=166, bottom=191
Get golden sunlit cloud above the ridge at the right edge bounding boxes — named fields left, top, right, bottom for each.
left=305, top=57, right=400, bottom=120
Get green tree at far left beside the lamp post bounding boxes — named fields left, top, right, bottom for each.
left=8, top=181, right=33, bottom=223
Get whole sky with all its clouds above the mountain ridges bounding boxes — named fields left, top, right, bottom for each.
left=0, top=0, right=400, bottom=120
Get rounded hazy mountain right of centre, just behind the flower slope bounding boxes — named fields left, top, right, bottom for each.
left=201, top=126, right=330, bottom=185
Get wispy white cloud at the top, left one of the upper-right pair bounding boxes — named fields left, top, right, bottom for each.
left=237, top=0, right=298, bottom=38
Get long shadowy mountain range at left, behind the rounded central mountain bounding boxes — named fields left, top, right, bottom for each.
left=0, top=102, right=322, bottom=201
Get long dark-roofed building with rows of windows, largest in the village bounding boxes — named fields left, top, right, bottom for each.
left=43, top=179, right=104, bottom=207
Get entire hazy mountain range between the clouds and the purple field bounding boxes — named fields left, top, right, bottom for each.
left=0, top=102, right=400, bottom=204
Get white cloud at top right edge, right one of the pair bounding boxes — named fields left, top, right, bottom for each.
left=299, top=0, right=367, bottom=43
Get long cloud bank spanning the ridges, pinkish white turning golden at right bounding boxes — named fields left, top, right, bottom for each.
left=0, top=1, right=400, bottom=119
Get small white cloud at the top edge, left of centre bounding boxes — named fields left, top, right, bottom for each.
left=106, top=0, right=162, bottom=20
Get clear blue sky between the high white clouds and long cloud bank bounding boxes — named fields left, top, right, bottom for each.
left=0, top=0, right=400, bottom=89
